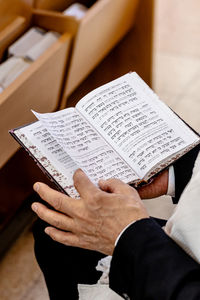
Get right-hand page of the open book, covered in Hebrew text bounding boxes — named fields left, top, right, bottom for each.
left=76, top=73, right=199, bottom=178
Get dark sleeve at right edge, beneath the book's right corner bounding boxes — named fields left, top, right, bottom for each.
left=173, top=145, right=200, bottom=203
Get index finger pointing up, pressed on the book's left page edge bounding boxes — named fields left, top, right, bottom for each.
left=73, top=169, right=99, bottom=198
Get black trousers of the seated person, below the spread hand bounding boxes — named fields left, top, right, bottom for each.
left=33, top=219, right=166, bottom=300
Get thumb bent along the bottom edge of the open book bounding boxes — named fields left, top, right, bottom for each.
left=99, top=178, right=137, bottom=196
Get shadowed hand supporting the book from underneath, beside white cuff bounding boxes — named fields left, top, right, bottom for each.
left=137, top=169, right=169, bottom=199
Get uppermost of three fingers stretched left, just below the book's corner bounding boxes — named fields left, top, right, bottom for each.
left=33, top=182, right=77, bottom=216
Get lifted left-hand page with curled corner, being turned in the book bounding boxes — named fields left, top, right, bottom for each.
left=34, top=108, right=138, bottom=184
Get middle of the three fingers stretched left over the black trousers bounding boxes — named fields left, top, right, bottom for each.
left=31, top=202, right=75, bottom=231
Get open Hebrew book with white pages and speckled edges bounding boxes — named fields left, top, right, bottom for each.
left=10, top=73, right=200, bottom=197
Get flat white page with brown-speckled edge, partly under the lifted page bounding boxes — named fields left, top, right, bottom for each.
left=15, top=121, right=78, bottom=197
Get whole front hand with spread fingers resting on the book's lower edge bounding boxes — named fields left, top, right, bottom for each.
left=32, top=169, right=149, bottom=255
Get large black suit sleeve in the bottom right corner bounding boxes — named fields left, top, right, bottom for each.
left=109, top=219, right=200, bottom=300
